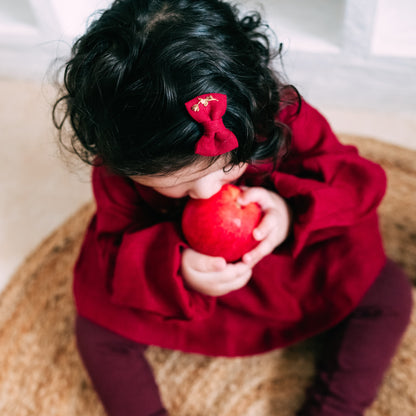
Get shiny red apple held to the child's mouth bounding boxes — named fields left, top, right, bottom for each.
left=182, top=184, right=263, bottom=262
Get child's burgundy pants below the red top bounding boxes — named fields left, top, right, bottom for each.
left=76, top=262, right=412, bottom=416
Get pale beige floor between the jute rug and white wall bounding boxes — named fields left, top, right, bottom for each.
left=0, top=79, right=416, bottom=291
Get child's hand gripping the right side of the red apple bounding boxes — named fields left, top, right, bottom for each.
left=239, top=187, right=292, bottom=267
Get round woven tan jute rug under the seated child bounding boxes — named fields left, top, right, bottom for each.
left=0, top=136, right=416, bottom=416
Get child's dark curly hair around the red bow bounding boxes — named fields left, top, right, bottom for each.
left=53, top=0, right=298, bottom=176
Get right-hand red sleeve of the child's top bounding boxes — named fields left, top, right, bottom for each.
left=272, top=102, right=386, bottom=256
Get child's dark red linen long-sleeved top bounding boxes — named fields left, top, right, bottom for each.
left=74, top=102, right=386, bottom=356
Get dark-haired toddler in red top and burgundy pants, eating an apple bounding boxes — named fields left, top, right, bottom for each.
left=54, top=0, right=411, bottom=416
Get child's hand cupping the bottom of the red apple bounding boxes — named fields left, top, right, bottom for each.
left=182, top=248, right=252, bottom=296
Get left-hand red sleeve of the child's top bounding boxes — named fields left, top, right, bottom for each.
left=87, top=167, right=214, bottom=319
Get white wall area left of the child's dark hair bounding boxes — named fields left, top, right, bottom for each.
left=0, top=0, right=110, bottom=80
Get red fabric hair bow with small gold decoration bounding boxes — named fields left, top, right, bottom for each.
left=185, top=93, right=238, bottom=156
